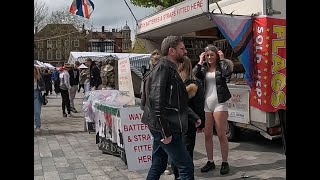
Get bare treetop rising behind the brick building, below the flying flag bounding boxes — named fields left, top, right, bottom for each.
left=47, top=7, right=89, bottom=29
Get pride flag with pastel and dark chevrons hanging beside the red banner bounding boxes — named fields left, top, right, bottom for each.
left=211, top=13, right=254, bottom=87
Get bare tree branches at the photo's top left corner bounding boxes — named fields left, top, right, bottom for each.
left=33, top=0, right=48, bottom=30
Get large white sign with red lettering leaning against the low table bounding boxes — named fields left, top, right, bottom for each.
left=120, top=107, right=153, bottom=171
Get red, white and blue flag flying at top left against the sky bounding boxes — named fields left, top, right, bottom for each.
left=69, top=0, right=94, bottom=19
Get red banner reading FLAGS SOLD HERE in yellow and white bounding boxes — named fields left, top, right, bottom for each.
left=250, top=16, right=286, bottom=112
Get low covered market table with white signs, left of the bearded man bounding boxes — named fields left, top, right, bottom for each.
left=82, top=54, right=152, bottom=171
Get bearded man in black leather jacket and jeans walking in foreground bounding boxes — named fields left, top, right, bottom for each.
left=142, top=36, right=201, bottom=180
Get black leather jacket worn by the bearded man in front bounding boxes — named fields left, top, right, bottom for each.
left=141, top=57, right=200, bottom=137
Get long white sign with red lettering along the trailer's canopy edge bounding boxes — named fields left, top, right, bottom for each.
left=137, top=0, right=209, bottom=34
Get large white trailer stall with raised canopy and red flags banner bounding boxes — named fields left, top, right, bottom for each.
left=136, top=0, right=286, bottom=140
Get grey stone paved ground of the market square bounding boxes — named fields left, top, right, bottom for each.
left=34, top=93, right=286, bottom=180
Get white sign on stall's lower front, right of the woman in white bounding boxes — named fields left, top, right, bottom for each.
left=227, top=88, right=250, bottom=124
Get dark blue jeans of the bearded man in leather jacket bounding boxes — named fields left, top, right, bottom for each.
left=147, top=130, right=194, bottom=180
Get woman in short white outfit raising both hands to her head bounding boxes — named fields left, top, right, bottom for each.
left=193, top=45, right=233, bottom=174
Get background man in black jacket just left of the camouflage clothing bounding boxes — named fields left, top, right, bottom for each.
left=85, top=58, right=102, bottom=90
